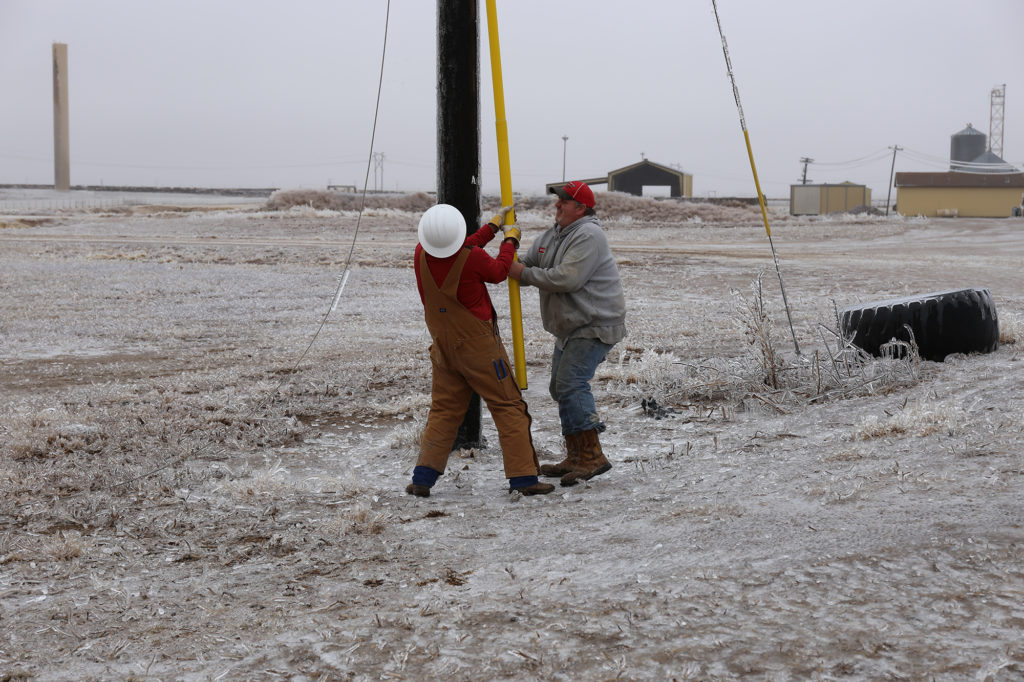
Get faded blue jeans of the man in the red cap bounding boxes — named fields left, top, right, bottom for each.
left=548, top=339, right=611, bottom=435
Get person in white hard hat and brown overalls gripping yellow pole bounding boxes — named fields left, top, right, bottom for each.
left=406, top=204, right=554, bottom=498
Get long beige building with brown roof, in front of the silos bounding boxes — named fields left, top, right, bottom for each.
left=896, top=172, right=1024, bottom=218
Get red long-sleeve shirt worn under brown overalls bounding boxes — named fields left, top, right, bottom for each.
left=414, top=223, right=515, bottom=321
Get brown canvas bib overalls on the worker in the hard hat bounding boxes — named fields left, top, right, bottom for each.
left=416, top=248, right=538, bottom=478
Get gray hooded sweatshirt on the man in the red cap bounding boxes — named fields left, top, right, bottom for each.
left=519, top=215, right=626, bottom=347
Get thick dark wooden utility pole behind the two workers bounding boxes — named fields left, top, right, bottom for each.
left=437, top=0, right=484, bottom=450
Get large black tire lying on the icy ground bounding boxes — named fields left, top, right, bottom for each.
left=840, top=289, right=999, bottom=363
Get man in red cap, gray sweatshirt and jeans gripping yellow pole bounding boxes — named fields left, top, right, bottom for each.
left=509, top=180, right=626, bottom=485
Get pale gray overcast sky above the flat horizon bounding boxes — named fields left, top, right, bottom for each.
left=0, top=0, right=1024, bottom=199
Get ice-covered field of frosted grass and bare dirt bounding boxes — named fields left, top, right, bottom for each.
left=0, top=188, right=1024, bottom=680
